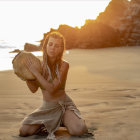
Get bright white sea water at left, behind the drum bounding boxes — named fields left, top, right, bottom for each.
left=0, top=40, right=42, bottom=71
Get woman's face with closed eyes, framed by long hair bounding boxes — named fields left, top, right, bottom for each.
left=47, top=37, right=62, bottom=59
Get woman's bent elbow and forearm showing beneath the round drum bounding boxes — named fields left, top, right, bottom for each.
left=26, top=80, right=39, bottom=93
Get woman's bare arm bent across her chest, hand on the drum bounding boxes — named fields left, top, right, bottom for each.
left=26, top=59, right=69, bottom=94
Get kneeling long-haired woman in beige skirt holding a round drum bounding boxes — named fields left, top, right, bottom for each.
left=19, top=32, right=87, bottom=139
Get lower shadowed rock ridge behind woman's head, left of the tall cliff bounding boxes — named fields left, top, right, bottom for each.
left=41, top=20, right=120, bottom=49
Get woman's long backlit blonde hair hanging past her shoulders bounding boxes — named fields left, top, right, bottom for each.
left=42, top=32, right=65, bottom=79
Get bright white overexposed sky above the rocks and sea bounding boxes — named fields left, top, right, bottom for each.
left=0, top=0, right=110, bottom=42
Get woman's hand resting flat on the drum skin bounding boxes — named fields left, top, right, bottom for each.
left=25, top=57, right=38, bottom=76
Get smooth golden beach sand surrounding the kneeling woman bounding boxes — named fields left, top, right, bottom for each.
left=0, top=47, right=140, bottom=140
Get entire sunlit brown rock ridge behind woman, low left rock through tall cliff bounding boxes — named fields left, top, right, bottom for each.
left=24, top=0, right=140, bottom=51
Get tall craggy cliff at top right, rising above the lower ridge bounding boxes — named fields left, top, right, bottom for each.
left=97, top=0, right=140, bottom=46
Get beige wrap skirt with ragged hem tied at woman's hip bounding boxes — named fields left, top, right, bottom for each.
left=22, top=95, right=81, bottom=140
